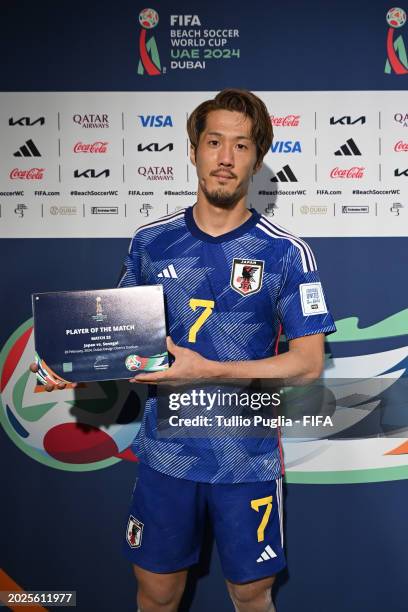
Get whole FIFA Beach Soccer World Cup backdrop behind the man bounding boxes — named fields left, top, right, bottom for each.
left=0, top=0, right=408, bottom=612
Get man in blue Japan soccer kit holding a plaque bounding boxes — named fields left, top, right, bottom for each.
left=34, top=90, right=335, bottom=612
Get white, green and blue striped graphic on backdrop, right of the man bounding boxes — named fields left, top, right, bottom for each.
left=283, top=309, right=408, bottom=484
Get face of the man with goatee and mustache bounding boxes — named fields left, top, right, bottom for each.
left=190, top=110, right=259, bottom=208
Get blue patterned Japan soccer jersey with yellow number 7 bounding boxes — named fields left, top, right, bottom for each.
left=120, top=207, right=336, bottom=483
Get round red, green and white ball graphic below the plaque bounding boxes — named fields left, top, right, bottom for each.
left=0, top=319, right=141, bottom=472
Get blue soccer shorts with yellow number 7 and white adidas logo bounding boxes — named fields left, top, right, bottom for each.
left=124, top=463, right=286, bottom=583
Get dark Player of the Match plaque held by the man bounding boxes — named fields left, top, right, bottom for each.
left=32, top=285, right=169, bottom=384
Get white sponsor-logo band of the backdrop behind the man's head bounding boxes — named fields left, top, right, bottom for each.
left=0, top=91, right=408, bottom=238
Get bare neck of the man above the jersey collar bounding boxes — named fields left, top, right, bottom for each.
left=193, top=198, right=251, bottom=238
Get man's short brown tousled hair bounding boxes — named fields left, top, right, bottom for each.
left=187, top=89, right=273, bottom=165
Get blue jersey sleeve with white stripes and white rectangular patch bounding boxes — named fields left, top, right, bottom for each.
left=277, top=240, right=336, bottom=340
